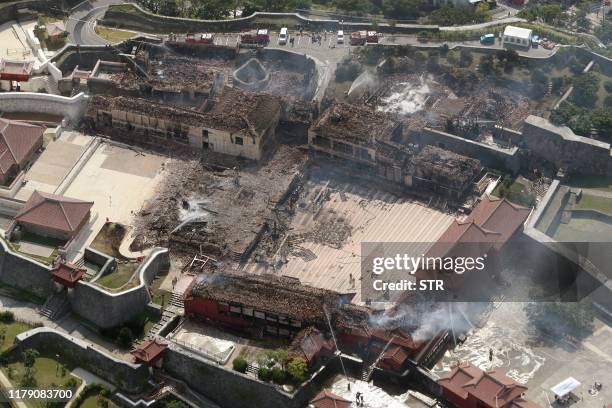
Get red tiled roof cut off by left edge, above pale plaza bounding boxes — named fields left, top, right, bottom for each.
left=0, top=118, right=45, bottom=174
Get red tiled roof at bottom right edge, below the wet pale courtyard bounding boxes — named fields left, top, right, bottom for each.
left=438, top=363, right=538, bottom=408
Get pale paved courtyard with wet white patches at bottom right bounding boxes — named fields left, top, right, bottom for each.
left=433, top=302, right=612, bottom=408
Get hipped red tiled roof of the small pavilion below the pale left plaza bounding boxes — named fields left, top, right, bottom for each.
left=15, top=191, right=93, bottom=232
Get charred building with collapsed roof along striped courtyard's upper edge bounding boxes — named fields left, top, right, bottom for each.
left=309, top=103, right=482, bottom=199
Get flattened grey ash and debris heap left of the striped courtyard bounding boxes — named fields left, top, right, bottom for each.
left=135, top=146, right=306, bottom=262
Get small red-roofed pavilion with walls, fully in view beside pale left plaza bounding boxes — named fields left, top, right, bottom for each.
left=14, top=191, right=93, bottom=240
